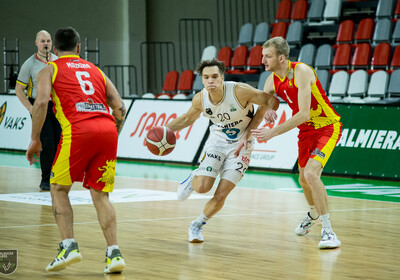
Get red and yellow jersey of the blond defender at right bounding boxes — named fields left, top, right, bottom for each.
left=273, top=61, right=340, bottom=131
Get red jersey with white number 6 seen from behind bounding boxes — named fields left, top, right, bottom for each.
left=49, top=55, right=115, bottom=130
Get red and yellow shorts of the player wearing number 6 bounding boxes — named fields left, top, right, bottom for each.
left=50, top=118, right=118, bottom=192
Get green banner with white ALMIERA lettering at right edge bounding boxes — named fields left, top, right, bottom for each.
left=324, top=105, right=400, bottom=178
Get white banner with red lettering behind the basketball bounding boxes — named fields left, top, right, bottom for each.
left=117, top=99, right=208, bottom=163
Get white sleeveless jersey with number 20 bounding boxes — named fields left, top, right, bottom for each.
left=201, top=82, right=254, bottom=142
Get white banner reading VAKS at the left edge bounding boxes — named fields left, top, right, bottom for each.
left=0, top=95, right=32, bottom=150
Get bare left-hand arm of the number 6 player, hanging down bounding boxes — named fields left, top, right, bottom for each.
left=26, top=64, right=54, bottom=164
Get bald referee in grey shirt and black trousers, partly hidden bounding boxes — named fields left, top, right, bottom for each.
left=15, top=30, right=61, bottom=191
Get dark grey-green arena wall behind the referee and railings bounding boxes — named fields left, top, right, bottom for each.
left=0, top=0, right=279, bottom=96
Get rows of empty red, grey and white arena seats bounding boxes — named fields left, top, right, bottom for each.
left=163, top=0, right=400, bottom=103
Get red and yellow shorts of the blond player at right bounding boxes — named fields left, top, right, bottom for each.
left=298, top=122, right=342, bottom=168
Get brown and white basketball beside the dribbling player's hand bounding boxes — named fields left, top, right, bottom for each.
left=146, top=126, right=176, bottom=156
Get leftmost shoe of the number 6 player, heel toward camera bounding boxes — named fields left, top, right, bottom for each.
left=46, top=242, right=82, bottom=271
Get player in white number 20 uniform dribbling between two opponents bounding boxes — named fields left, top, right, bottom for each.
left=166, top=59, right=279, bottom=243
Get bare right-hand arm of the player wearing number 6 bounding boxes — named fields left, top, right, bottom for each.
left=103, top=73, right=126, bottom=134
